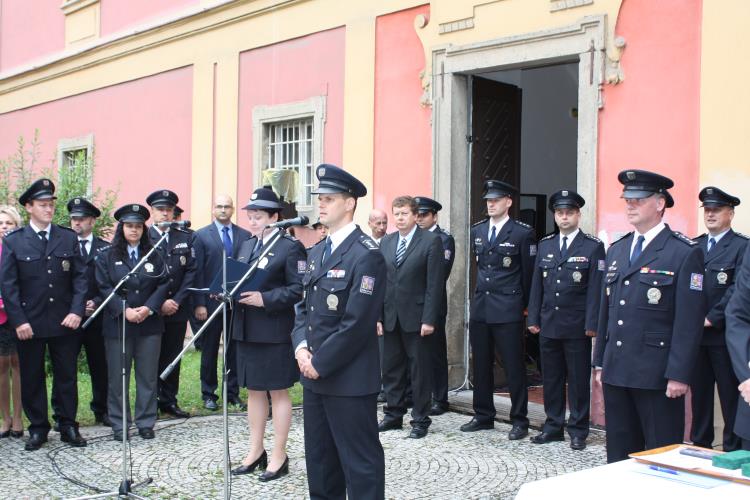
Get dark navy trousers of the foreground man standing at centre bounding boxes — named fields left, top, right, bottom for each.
left=303, top=389, right=385, bottom=500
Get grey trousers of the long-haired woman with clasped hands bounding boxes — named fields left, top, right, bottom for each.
left=104, top=334, right=161, bottom=432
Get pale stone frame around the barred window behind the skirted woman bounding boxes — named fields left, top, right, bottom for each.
left=253, top=96, right=326, bottom=220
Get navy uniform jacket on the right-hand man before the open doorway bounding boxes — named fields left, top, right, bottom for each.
left=528, top=231, right=604, bottom=339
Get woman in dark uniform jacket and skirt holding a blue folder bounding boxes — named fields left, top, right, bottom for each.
left=232, top=188, right=307, bottom=481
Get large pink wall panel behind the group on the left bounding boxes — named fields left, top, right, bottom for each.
left=0, top=67, right=193, bottom=218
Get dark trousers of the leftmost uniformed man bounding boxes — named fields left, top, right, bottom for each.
left=18, top=332, right=80, bottom=436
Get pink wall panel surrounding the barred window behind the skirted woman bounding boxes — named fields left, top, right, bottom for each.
left=236, top=28, right=346, bottom=244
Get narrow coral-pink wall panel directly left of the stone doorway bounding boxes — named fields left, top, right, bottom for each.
left=372, top=5, right=432, bottom=232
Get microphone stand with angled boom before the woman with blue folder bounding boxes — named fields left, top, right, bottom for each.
left=159, top=226, right=286, bottom=500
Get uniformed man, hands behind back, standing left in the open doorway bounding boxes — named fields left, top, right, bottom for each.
left=461, top=180, right=536, bottom=440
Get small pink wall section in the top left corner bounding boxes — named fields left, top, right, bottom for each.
left=0, top=0, right=65, bottom=72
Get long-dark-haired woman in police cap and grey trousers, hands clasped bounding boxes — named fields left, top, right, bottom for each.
left=96, top=204, right=169, bottom=441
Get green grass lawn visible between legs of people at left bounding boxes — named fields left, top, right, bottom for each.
left=37, top=349, right=302, bottom=426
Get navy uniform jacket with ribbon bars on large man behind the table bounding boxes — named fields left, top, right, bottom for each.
left=594, top=226, right=706, bottom=390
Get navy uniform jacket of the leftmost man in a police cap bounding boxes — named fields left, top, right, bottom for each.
left=0, top=224, right=87, bottom=338
